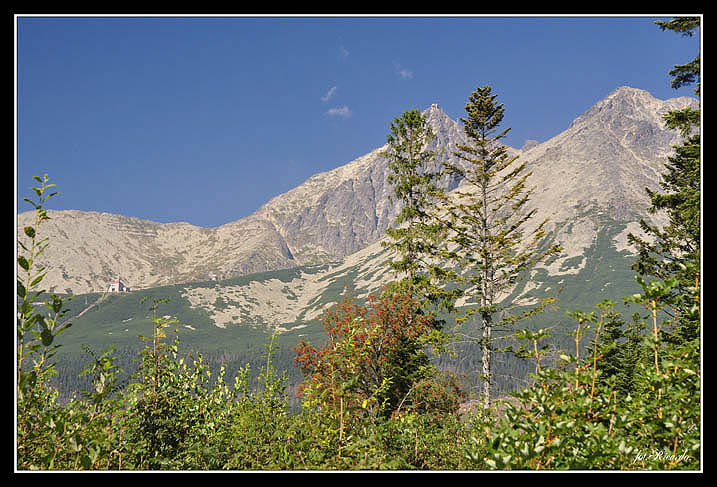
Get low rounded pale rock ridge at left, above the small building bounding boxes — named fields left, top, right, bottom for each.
left=18, top=210, right=294, bottom=294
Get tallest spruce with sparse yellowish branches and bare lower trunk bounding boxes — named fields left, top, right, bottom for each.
left=444, top=86, right=561, bottom=407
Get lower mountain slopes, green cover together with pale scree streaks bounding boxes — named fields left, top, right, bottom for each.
left=49, top=212, right=639, bottom=404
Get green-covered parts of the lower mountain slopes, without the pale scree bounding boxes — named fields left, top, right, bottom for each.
left=46, top=215, right=639, bottom=406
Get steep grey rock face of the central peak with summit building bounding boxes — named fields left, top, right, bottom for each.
left=256, top=105, right=465, bottom=264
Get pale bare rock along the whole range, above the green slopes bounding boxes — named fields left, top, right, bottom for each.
left=18, top=87, right=698, bottom=294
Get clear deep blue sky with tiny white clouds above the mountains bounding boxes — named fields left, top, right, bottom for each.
left=16, top=16, right=700, bottom=227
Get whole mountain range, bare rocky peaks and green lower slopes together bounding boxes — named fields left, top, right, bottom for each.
left=18, top=87, right=699, bottom=400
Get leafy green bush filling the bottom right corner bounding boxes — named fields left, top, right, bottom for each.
left=469, top=294, right=700, bottom=470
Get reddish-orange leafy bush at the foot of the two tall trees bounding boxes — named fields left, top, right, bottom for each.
left=296, top=293, right=457, bottom=418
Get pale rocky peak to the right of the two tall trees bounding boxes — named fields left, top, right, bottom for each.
left=522, top=87, right=697, bottom=222
